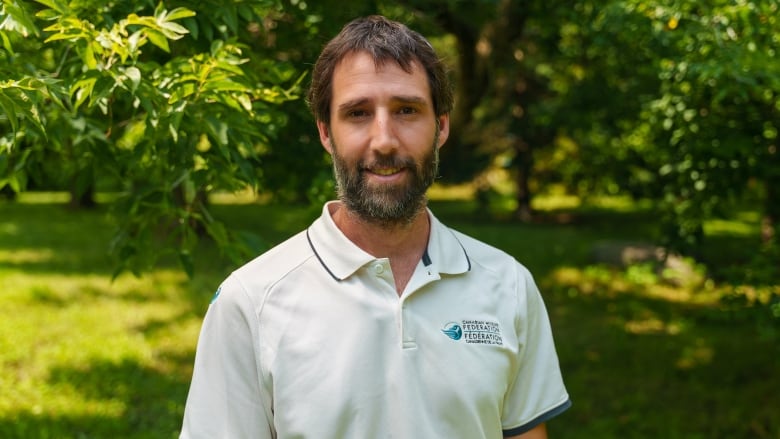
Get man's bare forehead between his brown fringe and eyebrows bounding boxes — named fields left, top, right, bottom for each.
left=331, top=52, right=432, bottom=106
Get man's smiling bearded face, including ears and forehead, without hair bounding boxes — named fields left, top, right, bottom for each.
left=317, top=53, right=449, bottom=224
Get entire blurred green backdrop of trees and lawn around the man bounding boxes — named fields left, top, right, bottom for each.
left=0, top=0, right=780, bottom=439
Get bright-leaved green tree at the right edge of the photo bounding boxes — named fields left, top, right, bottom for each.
left=649, top=1, right=780, bottom=251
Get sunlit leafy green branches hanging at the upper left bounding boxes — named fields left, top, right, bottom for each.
left=0, top=0, right=302, bottom=273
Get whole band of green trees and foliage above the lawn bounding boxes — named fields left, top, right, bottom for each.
left=0, top=0, right=780, bottom=272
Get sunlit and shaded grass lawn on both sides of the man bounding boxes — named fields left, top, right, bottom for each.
left=0, top=194, right=780, bottom=439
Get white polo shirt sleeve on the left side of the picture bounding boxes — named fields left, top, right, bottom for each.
left=180, top=277, right=273, bottom=439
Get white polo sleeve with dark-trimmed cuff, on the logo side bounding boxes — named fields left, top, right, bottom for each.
left=501, top=265, right=571, bottom=436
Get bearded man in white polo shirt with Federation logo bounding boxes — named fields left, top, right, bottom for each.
left=181, top=16, right=570, bottom=439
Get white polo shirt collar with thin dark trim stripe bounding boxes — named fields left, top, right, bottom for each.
left=306, top=201, right=471, bottom=280
